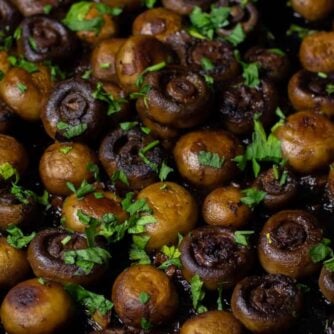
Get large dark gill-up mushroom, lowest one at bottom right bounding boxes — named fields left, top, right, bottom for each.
left=231, top=275, right=302, bottom=334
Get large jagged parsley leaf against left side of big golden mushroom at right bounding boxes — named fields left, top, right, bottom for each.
left=234, top=115, right=284, bottom=177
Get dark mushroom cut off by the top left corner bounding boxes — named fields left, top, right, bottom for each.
left=0, top=0, right=21, bottom=43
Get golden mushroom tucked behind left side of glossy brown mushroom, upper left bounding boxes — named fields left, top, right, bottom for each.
left=90, top=38, right=126, bottom=82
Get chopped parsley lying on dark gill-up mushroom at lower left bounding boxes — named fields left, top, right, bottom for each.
left=64, top=247, right=111, bottom=274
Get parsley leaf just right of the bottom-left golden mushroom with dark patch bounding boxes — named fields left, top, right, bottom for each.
left=65, top=283, right=114, bottom=315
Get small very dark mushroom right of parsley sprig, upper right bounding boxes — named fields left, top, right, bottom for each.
left=244, top=46, right=290, bottom=82
